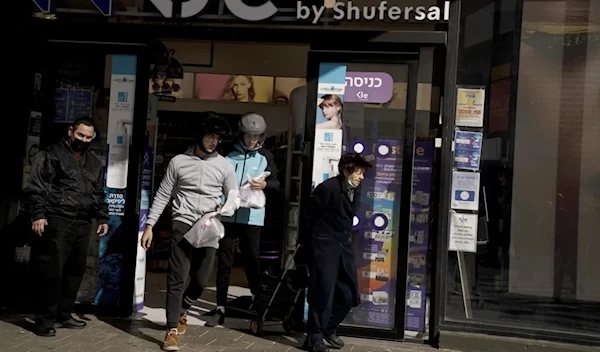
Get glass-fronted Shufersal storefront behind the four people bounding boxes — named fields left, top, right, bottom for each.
left=2, top=0, right=600, bottom=348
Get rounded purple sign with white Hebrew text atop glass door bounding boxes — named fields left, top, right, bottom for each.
left=344, top=72, right=394, bottom=103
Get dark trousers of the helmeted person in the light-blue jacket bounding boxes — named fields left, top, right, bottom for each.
left=217, top=224, right=262, bottom=307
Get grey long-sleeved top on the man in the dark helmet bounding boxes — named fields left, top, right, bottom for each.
left=146, top=146, right=238, bottom=226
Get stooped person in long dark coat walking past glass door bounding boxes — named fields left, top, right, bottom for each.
left=304, top=153, right=371, bottom=352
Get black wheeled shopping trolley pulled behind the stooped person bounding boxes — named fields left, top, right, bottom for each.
left=250, top=245, right=306, bottom=336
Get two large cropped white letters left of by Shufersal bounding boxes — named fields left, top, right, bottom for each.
left=150, top=0, right=277, bottom=21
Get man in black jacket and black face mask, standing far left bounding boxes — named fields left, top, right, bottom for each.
left=23, top=118, right=108, bottom=337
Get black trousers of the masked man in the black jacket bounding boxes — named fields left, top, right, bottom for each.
left=32, top=217, right=92, bottom=327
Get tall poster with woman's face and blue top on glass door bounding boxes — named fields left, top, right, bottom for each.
left=312, top=63, right=346, bottom=189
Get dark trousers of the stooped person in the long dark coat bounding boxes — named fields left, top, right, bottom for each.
left=306, top=253, right=353, bottom=347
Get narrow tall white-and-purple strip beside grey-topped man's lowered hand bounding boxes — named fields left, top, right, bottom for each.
left=133, top=146, right=154, bottom=312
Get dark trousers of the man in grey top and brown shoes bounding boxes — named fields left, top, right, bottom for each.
left=167, top=221, right=217, bottom=329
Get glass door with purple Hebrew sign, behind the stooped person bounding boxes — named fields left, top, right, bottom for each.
left=302, top=52, right=425, bottom=340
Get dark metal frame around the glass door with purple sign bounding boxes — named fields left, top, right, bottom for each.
left=299, top=50, right=419, bottom=340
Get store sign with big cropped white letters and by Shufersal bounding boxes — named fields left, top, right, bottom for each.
left=150, top=0, right=450, bottom=23
